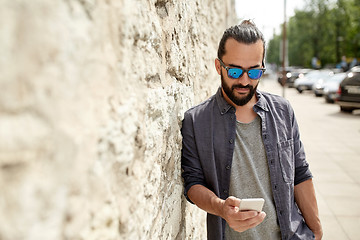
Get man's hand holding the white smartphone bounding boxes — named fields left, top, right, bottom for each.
left=221, top=197, right=266, bottom=232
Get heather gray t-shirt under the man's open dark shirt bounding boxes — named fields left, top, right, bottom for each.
left=225, top=116, right=281, bottom=240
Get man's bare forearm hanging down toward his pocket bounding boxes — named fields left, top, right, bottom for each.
left=294, top=179, right=323, bottom=240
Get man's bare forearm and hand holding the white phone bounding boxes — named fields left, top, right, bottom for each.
left=187, top=184, right=266, bottom=232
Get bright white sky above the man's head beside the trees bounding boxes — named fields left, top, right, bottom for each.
left=235, top=0, right=306, bottom=42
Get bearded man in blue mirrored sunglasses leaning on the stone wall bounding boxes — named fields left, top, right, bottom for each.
left=181, top=21, right=322, bottom=240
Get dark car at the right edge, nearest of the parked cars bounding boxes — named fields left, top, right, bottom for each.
left=336, top=66, right=360, bottom=112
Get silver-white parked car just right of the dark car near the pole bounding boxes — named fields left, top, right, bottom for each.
left=294, top=69, right=334, bottom=93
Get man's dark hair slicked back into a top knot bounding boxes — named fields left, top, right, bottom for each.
left=218, top=20, right=265, bottom=67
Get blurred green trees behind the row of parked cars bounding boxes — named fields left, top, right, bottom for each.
left=267, top=0, right=360, bottom=67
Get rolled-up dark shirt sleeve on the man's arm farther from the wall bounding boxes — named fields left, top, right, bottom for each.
left=288, top=101, right=313, bottom=185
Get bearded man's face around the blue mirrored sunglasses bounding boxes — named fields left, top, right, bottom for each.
left=216, top=38, right=263, bottom=106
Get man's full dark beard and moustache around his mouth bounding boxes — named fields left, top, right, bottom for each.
left=221, top=73, right=259, bottom=106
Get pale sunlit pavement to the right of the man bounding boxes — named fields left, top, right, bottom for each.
left=258, top=77, right=360, bottom=240
